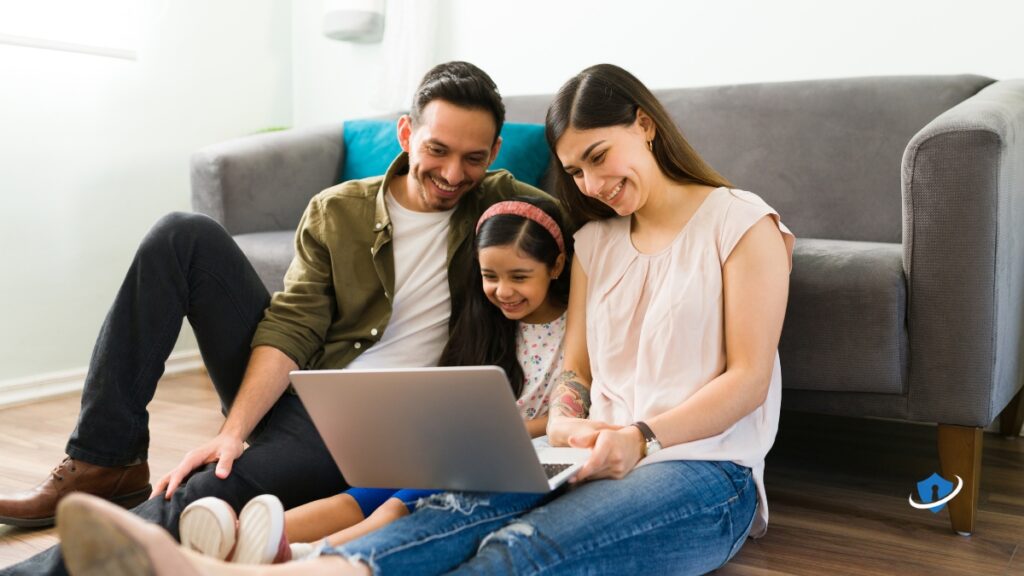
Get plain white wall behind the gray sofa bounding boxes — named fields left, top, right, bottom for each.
left=6, top=0, right=1024, bottom=393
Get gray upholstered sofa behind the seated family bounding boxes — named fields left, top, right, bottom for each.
left=191, top=76, right=1024, bottom=533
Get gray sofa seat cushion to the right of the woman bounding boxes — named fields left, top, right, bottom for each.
left=778, top=239, right=908, bottom=395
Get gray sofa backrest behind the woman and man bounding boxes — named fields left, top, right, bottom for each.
left=505, top=75, right=993, bottom=242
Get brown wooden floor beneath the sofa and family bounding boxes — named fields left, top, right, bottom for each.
left=0, top=374, right=1024, bottom=576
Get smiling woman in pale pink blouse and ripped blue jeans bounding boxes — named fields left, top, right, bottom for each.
left=58, top=65, right=794, bottom=574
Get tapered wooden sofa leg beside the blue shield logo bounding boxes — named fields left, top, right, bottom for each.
left=939, top=424, right=982, bottom=536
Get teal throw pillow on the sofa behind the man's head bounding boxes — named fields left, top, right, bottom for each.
left=341, top=120, right=551, bottom=187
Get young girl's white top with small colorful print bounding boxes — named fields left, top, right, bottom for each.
left=515, top=313, right=565, bottom=420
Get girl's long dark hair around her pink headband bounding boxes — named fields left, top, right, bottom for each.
left=439, top=196, right=572, bottom=398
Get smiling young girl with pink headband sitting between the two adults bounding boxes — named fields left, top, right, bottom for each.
left=167, top=197, right=570, bottom=564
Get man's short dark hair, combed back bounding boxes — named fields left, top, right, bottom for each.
left=409, top=61, right=505, bottom=141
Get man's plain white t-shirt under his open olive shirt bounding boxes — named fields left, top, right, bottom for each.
left=347, top=192, right=455, bottom=369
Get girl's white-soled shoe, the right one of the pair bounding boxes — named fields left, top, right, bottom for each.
left=231, top=494, right=292, bottom=564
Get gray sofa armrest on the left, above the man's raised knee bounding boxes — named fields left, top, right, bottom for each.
left=191, top=124, right=344, bottom=235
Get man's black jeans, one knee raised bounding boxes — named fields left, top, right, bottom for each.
left=0, top=213, right=347, bottom=575
